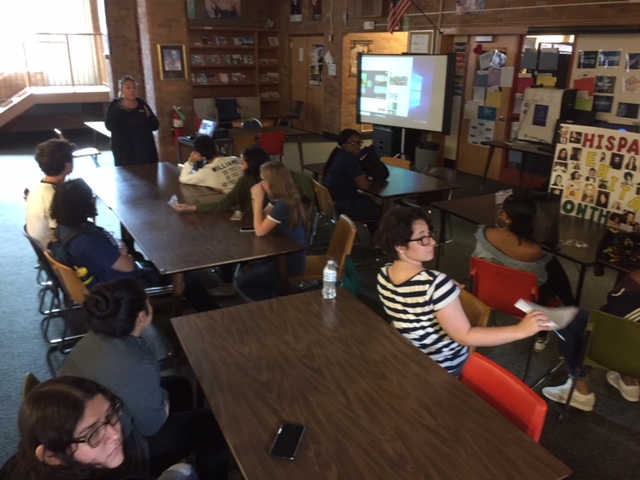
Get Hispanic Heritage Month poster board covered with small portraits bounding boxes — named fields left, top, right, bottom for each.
left=549, top=124, right=640, bottom=231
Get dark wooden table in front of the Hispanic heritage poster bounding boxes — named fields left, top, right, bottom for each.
left=431, top=194, right=608, bottom=303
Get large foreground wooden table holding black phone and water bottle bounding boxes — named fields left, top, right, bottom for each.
left=172, top=287, right=571, bottom=480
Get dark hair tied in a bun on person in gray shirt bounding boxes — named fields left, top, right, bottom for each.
left=84, top=278, right=147, bottom=338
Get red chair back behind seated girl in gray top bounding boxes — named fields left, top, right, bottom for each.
left=471, top=257, right=539, bottom=318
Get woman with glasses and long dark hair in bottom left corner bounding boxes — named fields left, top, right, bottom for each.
left=0, top=377, right=197, bottom=480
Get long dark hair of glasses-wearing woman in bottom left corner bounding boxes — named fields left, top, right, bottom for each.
left=18, top=376, right=126, bottom=479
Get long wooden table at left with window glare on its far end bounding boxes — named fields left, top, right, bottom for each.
left=84, top=162, right=303, bottom=314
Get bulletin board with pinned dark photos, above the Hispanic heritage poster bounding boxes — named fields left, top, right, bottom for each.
left=571, top=34, right=640, bottom=125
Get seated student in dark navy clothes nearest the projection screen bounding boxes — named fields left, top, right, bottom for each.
left=324, top=128, right=382, bottom=234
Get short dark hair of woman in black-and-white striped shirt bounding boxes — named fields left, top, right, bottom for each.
left=374, top=207, right=433, bottom=258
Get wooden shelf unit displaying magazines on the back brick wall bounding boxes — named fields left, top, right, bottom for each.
left=188, top=26, right=281, bottom=118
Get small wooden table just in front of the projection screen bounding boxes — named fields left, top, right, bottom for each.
left=304, top=163, right=460, bottom=212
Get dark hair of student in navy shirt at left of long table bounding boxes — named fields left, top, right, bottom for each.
left=51, top=178, right=98, bottom=226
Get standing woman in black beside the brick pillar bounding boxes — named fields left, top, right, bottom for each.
left=105, top=76, right=160, bottom=167
